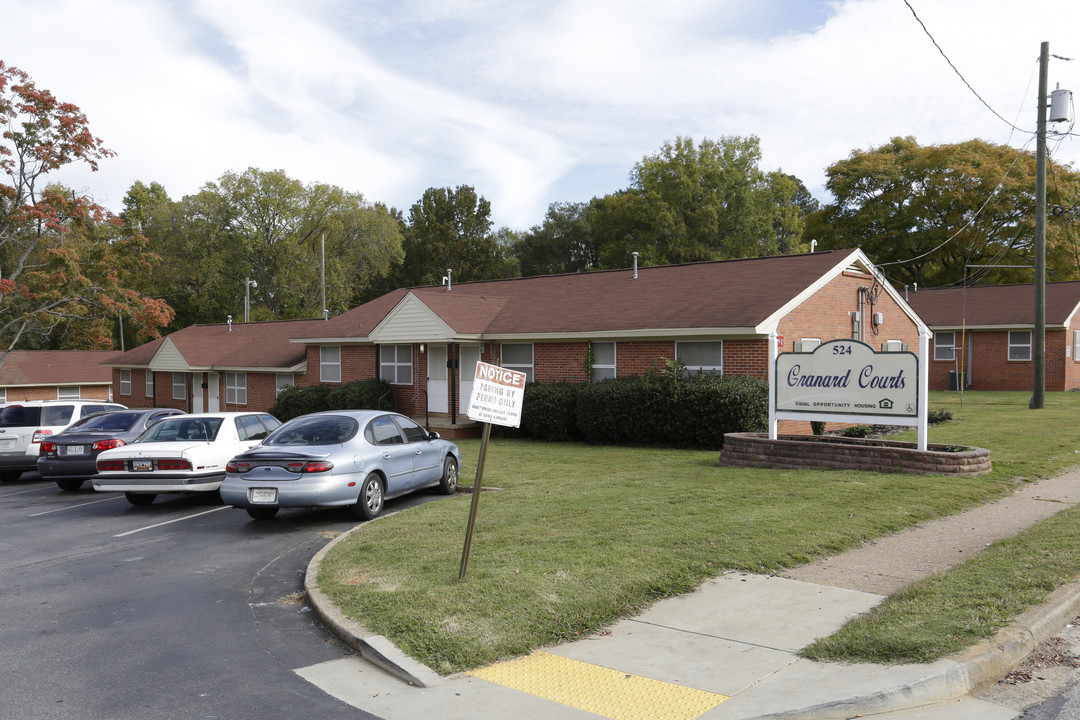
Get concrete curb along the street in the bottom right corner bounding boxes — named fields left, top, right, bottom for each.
left=760, top=582, right=1080, bottom=720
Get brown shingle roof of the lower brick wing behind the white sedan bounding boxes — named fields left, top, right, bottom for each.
left=111, top=320, right=325, bottom=369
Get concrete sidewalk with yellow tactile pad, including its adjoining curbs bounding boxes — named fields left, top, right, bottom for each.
left=297, top=474, right=1080, bottom=720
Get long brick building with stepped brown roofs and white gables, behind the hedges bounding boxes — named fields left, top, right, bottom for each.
left=103, top=249, right=919, bottom=436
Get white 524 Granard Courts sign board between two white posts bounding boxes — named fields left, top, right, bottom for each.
left=775, top=340, right=919, bottom=418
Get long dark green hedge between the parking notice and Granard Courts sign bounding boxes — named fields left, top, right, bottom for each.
left=491, top=372, right=769, bottom=449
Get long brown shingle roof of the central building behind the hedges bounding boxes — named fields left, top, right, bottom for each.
left=308, top=250, right=851, bottom=340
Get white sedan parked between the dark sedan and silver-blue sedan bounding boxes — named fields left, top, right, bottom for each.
left=91, top=412, right=281, bottom=505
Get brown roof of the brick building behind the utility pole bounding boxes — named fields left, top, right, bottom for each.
left=908, top=281, right=1080, bottom=328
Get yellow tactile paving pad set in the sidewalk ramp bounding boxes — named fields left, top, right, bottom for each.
left=470, top=652, right=728, bottom=720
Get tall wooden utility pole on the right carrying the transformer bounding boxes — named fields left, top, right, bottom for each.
left=1029, top=42, right=1050, bottom=410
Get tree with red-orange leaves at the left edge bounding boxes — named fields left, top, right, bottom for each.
left=0, top=60, right=173, bottom=363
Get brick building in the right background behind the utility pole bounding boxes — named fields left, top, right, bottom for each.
left=908, top=281, right=1080, bottom=391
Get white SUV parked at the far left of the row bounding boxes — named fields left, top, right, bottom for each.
left=0, top=400, right=125, bottom=481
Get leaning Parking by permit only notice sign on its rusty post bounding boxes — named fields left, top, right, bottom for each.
left=458, top=363, right=525, bottom=580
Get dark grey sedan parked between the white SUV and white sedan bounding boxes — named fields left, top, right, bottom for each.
left=38, top=408, right=184, bottom=490
